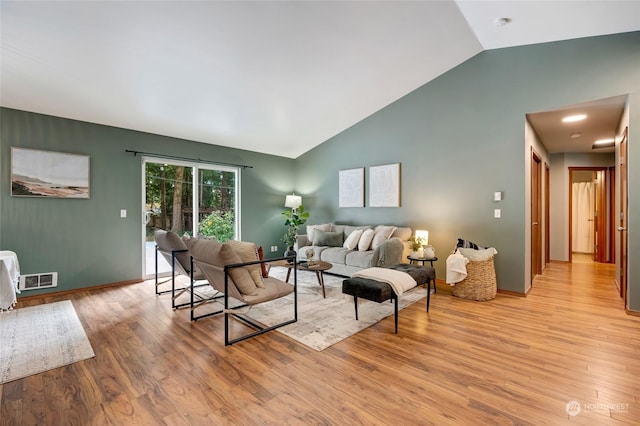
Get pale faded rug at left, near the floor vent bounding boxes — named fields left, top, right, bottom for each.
left=0, top=300, right=95, bottom=383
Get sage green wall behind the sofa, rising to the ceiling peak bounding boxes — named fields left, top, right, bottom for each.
left=296, top=32, right=640, bottom=310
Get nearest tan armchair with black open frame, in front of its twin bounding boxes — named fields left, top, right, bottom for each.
left=187, top=239, right=298, bottom=346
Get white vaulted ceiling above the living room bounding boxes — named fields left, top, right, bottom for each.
left=0, top=0, right=640, bottom=158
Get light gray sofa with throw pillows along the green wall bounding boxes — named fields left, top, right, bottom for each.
left=294, top=223, right=412, bottom=277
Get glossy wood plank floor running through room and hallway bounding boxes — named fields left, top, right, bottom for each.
left=0, top=263, right=640, bottom=425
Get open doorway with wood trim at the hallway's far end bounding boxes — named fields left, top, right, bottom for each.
left=568, top=167, right=613, bottom=263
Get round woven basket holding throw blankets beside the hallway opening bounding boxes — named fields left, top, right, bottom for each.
left=451, top=257, right=498, bottom=301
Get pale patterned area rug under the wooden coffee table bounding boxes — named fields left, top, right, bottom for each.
left=249, top=268, right=427, bottom=351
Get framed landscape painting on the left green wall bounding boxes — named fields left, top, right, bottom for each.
left=11, top=147, right=89, bottom=198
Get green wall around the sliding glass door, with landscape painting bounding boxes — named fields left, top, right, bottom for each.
left=0, top=108, right=294, bottom=295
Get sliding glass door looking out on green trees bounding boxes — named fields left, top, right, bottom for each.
left=143, top=158, right=239, bottom=279
